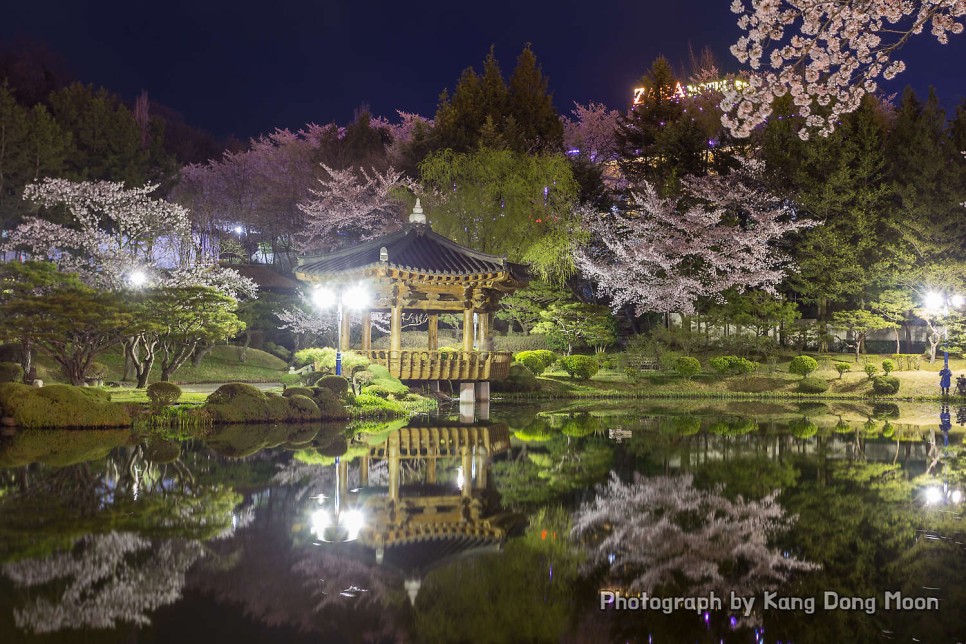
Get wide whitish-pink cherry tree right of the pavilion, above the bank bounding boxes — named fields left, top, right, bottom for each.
left=575, top=164, right=808, bottom=315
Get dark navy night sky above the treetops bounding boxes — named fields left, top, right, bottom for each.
left=0, top=0, right=966, bottom=137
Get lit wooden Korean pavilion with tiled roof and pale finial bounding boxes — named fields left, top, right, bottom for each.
left=294, top=200, right=528, bottom=386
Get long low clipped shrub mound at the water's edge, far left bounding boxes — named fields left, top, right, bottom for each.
left=0, top=382, right=131, bottom=427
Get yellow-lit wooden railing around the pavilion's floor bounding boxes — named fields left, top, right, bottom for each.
left=360, top=350, right=513, bottom=381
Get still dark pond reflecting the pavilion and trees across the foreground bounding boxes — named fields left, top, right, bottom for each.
left=0, top=400, right=966, bottom=644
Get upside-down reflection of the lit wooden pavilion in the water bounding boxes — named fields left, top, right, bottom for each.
left=324, top=423, right=526, bottom=601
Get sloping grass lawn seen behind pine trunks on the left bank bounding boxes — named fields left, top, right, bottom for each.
left=35, top=345, right=288, bottom=384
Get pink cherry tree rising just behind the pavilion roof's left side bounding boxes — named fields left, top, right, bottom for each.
left=297, top=164, right=408, bottom=250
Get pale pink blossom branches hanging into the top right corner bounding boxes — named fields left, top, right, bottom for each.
left=721, top=0, right=966, bottom=139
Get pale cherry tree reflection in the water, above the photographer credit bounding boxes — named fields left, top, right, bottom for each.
left=571, top=473, right=818, bottom=596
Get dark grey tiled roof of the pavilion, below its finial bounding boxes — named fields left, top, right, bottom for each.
left=295, top=224, right=527, bottom=280
